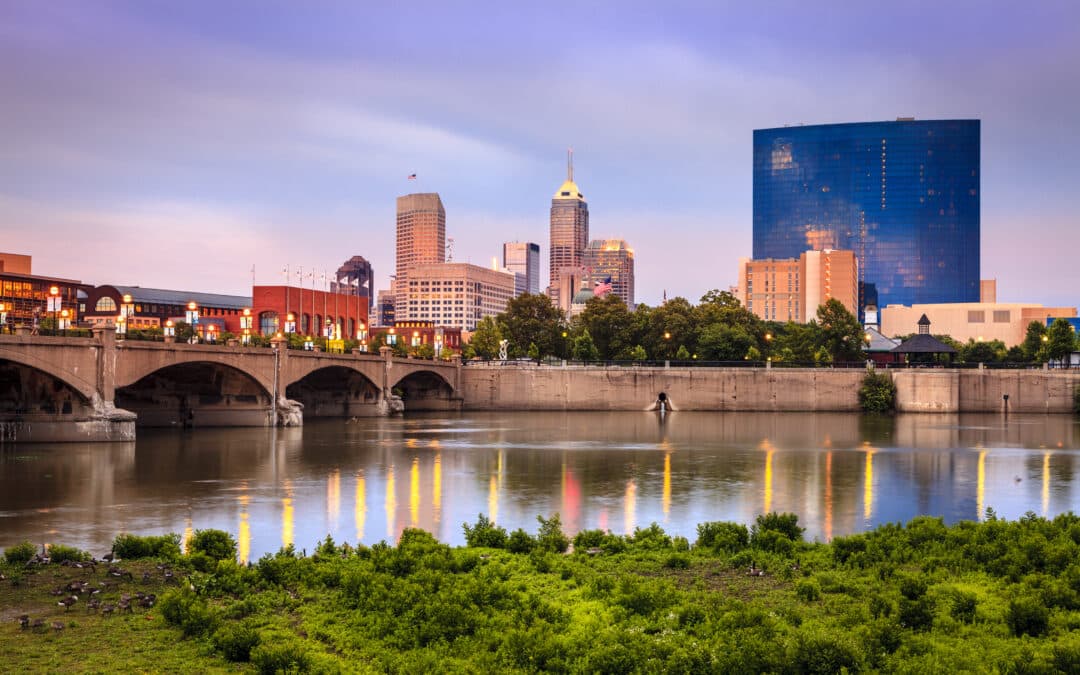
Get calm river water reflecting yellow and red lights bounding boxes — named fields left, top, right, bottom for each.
left=0, top=413, right=1080, bottom=559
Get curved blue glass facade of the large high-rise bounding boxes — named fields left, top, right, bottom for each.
left=754, top=120, right=980, bottom=307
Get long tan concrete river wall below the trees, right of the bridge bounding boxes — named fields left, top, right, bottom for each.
left=460, top=365, right=1080, bottom=414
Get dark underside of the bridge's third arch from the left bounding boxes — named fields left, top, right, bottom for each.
left=285, top=366, right=381, bottom=418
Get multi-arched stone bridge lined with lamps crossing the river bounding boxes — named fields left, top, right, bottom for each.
left=0, top=328, right=461, bottom=443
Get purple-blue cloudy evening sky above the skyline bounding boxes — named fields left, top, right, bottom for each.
left=0, top=0, right=1080, bottom=307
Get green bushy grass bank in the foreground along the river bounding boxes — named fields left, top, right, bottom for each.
left=6, top=513, right=1080, bottom=673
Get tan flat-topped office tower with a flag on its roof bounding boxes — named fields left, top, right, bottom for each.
left=391, top=192, right=446, bottom=307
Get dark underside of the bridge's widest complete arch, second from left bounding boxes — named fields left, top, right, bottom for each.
left=116, top=361, right=272, bottom=427
